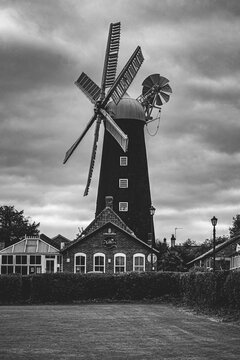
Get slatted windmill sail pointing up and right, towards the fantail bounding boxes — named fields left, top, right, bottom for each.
left=103, top=46, right=144, bottom=106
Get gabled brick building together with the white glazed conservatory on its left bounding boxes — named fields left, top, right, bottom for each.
left=0, top=196, right=158, bottom=275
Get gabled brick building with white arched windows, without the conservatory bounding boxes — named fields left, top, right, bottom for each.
left=62, top=197, right=158, bottom=273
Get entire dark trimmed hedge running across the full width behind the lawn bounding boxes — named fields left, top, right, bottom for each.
left=0, top=271, right=240, bottom=309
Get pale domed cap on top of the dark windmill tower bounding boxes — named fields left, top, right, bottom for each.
left=107, top=95, right=146, bottom=122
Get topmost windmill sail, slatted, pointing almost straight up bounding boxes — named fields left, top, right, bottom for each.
left=101, top=22, right=121, bottom=91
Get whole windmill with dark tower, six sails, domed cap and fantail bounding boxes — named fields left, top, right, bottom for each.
left=64, top=23, right=171, bottom=246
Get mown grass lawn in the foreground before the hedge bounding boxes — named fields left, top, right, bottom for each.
left=0, top=304, right=240, bottom=360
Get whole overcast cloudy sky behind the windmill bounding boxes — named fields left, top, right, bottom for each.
left=0, top=0, right=240, bottom=242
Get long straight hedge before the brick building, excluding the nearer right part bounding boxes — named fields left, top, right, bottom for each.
left=0, top=272, right=180, bottom=304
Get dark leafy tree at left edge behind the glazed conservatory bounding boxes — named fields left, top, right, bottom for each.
left=0, top=206, right=40, bottom=246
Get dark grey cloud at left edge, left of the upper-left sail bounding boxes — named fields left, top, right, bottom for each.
left=0, top=41, right=75, bottom=97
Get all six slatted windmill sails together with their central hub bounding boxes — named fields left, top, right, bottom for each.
left=63, top=22, right=144, bottom=196
